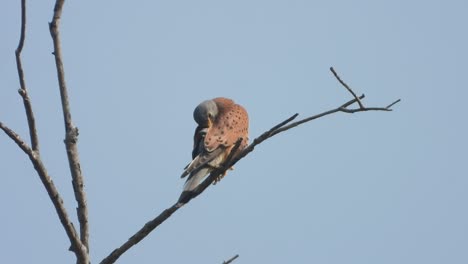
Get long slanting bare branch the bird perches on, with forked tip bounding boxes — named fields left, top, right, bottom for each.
left=100, top=68, right=400, bottom=264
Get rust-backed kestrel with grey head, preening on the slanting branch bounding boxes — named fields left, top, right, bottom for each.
left=179, top=97, right=249, bottom=203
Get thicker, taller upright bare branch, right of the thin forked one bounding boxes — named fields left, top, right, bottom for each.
left=49, top=0, right=89, bottom=255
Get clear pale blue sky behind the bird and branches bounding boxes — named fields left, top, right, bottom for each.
left=0, top=0, right=468, bottom=264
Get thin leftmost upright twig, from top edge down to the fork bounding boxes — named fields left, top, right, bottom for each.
left=15, top=0, right=39, bottom=152
